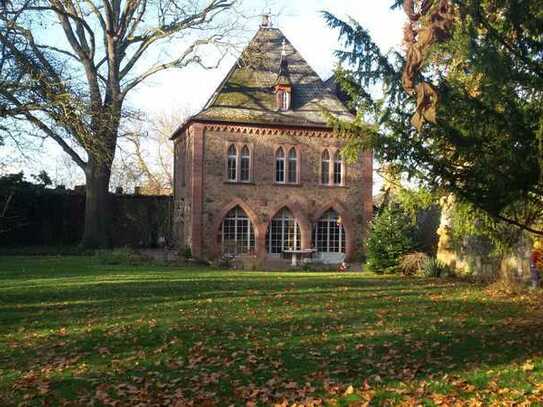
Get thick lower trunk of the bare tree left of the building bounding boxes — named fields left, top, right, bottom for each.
left=81, top=158, right=112, bottom=249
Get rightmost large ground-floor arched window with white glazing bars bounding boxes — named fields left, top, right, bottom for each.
left=313, top=209, right=345, bottom=253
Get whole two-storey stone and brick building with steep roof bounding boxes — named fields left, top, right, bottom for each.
left=172, top=17, right=372, bottom=263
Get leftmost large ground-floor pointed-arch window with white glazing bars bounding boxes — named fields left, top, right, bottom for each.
left=219, top=206, right=255, bottom=255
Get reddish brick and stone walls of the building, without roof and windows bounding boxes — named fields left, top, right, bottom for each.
left=174, top=121, right=373, bottom=261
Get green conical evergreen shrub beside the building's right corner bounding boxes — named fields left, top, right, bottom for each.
left=367, top=205, right=417, bottom=273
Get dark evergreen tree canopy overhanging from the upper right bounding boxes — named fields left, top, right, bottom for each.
left=325, top=0, right=543, bottom=234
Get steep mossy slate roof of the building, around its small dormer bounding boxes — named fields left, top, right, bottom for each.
left=192, top=27, right=353, bottom=127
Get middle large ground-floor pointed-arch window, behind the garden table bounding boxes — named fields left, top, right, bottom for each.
left=266, top=208, right=302, bottom=254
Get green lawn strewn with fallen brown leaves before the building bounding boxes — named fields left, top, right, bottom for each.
left=0, top=257, right=543, bottom=406
